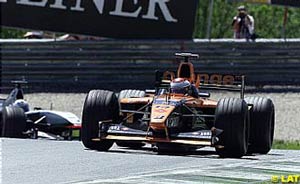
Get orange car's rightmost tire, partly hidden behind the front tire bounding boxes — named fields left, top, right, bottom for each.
left=245, top=97, right=275, bottom=154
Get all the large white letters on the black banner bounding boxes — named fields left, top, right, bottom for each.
left=14, top=0, right=178, bottom=22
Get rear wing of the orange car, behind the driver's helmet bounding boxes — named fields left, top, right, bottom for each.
left=155, top=71, right=245, bottom=99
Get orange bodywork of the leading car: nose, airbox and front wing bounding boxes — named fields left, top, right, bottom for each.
left=116, top=59, right=217, bottom=145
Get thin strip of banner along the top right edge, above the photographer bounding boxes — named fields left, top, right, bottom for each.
left=227, top=0, right=300, bottom=7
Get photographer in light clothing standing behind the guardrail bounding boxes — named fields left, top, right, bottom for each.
left=232, top=6, right=255, bottom=40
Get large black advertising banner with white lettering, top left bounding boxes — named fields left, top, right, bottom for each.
left=0, top=0, right=198, bottom=39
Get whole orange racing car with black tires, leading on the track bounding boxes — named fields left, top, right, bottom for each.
left=81, top=53, right=275, bottom=158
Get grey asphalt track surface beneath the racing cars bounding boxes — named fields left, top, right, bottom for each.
left=0, top=139, right=300, bottom=184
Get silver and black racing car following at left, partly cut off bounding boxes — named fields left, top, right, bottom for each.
left=0, top=81, right=81, bottom=140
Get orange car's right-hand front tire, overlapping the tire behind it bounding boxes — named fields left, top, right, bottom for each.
left=215, top=98, right=248, bottom=158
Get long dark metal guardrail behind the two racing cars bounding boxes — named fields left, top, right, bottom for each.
left=0, top=40, right=300, bottom=92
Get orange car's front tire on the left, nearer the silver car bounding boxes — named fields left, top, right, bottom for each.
left=81, top=90, right=119, bottom=151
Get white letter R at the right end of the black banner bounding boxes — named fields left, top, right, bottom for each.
left=143, top=0, right=178, bottom=22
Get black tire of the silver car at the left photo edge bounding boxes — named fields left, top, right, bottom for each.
left=2, top=107, right=27, bottom=138
